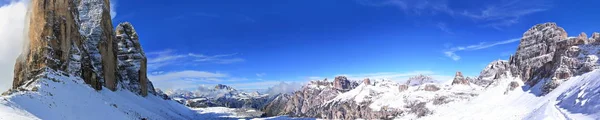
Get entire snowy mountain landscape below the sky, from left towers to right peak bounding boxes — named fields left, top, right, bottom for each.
left=0, top=0, right=600, bottom=120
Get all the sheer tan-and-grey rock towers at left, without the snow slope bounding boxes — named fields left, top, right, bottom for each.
left=12, top=0, right=155, bottom=96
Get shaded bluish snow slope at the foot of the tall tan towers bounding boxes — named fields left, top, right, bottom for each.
left=0, top=69, right=198, bottom=120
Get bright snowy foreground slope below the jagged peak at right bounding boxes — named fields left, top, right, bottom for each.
left=423, top=70, right=600, bottom=120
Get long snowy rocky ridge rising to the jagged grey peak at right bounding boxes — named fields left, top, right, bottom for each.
left=264, top=23, right=600, bottom=119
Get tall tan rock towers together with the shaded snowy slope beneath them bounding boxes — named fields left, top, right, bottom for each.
left=0, top=0, right=290, bottom=120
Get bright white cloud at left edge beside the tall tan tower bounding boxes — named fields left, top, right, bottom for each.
left=0, top=0, right=27, bottom=91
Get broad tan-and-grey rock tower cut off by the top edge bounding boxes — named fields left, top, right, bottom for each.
left=13, top=0, right=117, bottom=90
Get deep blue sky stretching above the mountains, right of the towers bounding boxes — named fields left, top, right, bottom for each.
left=106, top=0, right=600, bottom=89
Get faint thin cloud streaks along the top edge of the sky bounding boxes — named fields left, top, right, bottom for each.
left=356, top=0, right=552, bottom=29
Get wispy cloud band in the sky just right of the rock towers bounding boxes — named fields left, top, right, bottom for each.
left=146, top=49, right=246, bottom=71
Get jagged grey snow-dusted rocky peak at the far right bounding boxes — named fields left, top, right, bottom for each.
left=509, top=23, right=598, bottom=93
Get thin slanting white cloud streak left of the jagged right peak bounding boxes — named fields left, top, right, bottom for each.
left=444, top=38, right=521, bottom=61
